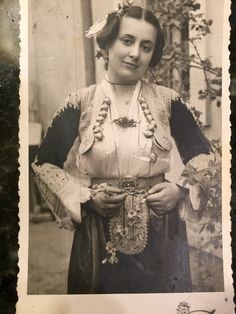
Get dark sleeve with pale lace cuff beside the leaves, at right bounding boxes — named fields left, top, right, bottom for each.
left=170, top=97, right=215, bottom=221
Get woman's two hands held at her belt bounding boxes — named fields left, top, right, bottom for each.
left=90, top=181, right=185, bottom=217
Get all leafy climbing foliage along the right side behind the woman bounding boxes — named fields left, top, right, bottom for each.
left=149, top=0, right=222, bottom=256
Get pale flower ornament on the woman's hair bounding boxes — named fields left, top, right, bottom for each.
left=85, top=1, right=133, bottom=38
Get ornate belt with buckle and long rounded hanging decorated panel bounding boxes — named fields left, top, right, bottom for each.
left=92, top=175, right=164, bottom=255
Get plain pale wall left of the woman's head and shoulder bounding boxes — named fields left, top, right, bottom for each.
left=29, top=0, right=86, bottom=129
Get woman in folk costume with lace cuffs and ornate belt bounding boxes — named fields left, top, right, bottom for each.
left=33, top=5, right=210, bottom=293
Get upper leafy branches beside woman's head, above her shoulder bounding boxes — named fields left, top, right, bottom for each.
left=149, top=0, right=221, bottom=101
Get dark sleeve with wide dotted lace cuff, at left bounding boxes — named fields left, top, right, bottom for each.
left=32, top=93, right=90, bottom=229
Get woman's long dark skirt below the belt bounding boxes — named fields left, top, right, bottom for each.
left=68, top=210, right=192, bottom=294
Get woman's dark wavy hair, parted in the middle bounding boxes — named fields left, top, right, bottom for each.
left=97, top=6, right=164, bottom=68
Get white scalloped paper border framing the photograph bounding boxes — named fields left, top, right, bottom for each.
left=16, top=0, right=234, bottom=314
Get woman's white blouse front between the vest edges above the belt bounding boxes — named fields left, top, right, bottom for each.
left=79, top=80, right=171, bottom=178
